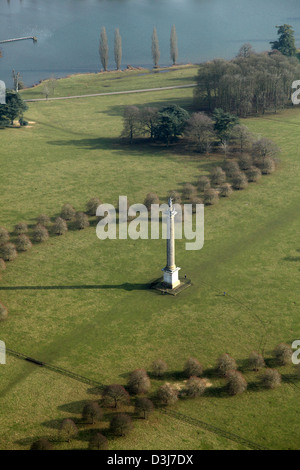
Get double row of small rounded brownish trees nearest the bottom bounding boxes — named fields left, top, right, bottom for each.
left=31, top=343, right=300, bottom=450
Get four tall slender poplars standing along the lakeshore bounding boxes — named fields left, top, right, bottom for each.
left=99, top=25, right=178, bottom=72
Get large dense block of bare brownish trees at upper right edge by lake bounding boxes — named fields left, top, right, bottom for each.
left=194, top=49, right=300, bottom=116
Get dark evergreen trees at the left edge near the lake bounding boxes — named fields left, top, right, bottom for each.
left=0, top=90, right=28, bottom=128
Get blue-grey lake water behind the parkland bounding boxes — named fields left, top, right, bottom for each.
left=0, top=0, right=300, bottom=86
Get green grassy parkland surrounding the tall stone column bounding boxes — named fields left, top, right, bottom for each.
left=0, top=69, right=300, bottom=449
